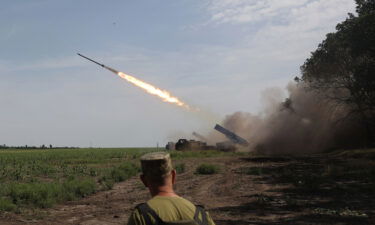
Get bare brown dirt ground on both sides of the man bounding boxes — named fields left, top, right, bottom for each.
left=0, top=156, right=375, bottom=225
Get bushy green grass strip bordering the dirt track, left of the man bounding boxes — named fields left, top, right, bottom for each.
left=0, top=163, right=139, bottom=211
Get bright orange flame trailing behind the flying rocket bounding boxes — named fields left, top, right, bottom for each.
left=117, top=72, right=191, bottom=110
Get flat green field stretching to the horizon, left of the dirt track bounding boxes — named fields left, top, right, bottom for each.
left=0, top=148, right=235, bottom=212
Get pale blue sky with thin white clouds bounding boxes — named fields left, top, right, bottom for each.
left=0, top=0, right=355, bottom=147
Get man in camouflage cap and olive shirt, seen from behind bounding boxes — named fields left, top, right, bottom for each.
left=128, top=152, right=215, bottom=225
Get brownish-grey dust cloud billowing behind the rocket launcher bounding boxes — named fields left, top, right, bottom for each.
left=214, top=82, right=365, bottom=154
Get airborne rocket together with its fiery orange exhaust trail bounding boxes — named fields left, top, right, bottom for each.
left=77, top=53, right=192, bottom=110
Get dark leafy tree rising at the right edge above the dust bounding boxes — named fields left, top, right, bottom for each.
left=301, top=0, right=375, bottom=144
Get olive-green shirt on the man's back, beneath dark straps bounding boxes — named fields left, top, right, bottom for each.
left=128, top=196, right=215, bottom=225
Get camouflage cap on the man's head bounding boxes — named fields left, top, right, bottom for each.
left=141, top=152, right=173, bottom=179
